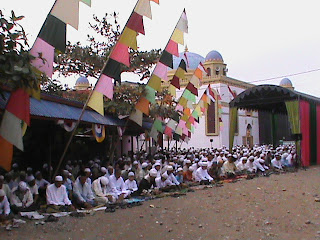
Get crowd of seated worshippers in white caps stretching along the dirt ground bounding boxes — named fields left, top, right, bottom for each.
left=0, top=145, right=297, bottom=221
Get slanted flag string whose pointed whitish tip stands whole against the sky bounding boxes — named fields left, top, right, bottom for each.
left=129, top=10, right=188, bottom=126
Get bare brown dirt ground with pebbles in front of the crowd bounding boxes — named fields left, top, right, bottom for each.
left=0, top=167, right=320, bottom=240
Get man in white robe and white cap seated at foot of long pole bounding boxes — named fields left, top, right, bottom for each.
left=46, top=176, right=74, bottom=213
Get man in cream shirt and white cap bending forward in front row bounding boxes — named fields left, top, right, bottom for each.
left=92, top=176, right=117, bottom=204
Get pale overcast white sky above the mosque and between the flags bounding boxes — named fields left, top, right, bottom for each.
left=0, top=0, right=320, bottom=97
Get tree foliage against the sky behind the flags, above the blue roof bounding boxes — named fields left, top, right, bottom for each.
left=55, top=12, right=161, bottom=80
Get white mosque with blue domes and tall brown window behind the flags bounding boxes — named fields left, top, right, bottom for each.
left=162, top=49, right=259, bottom=148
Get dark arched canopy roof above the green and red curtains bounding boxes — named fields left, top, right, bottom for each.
left=229, top=85, right=320, bottom=113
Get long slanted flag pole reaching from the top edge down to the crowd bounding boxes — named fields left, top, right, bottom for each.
left=53, top=0, right=140, bottom=177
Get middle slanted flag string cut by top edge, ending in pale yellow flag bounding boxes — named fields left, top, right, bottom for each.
left=88, top=0, right=159, bottom=115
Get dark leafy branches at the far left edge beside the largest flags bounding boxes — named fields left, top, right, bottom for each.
left=0, top=10, right=41, bottom=92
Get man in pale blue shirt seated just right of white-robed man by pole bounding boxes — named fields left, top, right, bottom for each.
left=73, top=172, right=95, bottom=209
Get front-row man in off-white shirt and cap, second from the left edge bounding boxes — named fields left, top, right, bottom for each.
left=10, top=181, right=35, bottom=213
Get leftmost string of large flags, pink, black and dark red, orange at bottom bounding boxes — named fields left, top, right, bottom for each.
left=0, top=0, right=91, bottom=171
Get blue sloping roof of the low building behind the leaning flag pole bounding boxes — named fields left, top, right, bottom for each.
left=0, top=92, right=124, bottom=126
